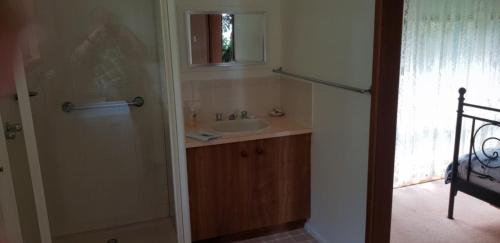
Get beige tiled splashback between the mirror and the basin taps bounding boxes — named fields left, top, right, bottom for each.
left=182, top=76, right=312, bottom=126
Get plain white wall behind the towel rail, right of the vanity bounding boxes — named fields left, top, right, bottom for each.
left=282, top=0, right=375, bottom=243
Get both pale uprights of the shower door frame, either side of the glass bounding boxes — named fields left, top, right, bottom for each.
left=10, top=0, right=191, bottom=243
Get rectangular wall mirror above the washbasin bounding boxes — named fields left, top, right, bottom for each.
left=186, top=11, right=267, bottom=66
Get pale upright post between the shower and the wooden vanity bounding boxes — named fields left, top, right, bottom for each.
left=159, top=0, right=192, bottom=243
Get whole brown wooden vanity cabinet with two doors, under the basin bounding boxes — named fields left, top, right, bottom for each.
left=187, top=134, right=311, bottom=241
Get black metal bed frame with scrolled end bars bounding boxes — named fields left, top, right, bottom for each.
left=448, top=88, right=500, bottom=219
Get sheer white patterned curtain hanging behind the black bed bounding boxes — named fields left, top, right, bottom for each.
left=394, top=0, right=500, bottom=187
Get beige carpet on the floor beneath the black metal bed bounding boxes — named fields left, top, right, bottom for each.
left=391, top=181, right=500, bottom=243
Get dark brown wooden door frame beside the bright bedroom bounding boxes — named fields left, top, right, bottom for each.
left=365, top=0, right=404, bottom=243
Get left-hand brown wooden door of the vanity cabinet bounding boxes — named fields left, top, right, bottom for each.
left=187, top=142, right=255, bottom=240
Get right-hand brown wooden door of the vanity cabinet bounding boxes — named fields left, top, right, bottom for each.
left=244, top=135, right=310, bottom=230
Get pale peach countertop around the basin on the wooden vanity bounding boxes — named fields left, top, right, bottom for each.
left=186, top=117, right=312, bottom=148
